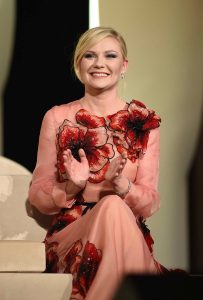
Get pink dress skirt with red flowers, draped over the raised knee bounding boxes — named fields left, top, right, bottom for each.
left=45, top=195, right=161, bottom=300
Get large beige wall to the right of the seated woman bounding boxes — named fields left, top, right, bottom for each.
left=100, top=0, right=203, bottom=269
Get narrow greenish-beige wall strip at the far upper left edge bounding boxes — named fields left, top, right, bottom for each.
left=0, top=0, right=15, bottom=155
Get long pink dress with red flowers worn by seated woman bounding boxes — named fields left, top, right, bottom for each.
left=29, top=100, right=166, bottom=300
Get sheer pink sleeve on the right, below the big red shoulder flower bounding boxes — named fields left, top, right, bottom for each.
left=124, top=128, right=160, bottom=218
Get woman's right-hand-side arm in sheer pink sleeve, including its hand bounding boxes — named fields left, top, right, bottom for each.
left=105, top=128, right=160, bottom=218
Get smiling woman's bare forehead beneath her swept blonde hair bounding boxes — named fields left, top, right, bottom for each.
left=87, top=36, right=121, bottom=52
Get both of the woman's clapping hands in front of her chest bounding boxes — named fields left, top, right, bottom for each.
left=63, top=149, right=129, bottom=193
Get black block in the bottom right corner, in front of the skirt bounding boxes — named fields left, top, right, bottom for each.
left=112, top=273, right=203, bottom=300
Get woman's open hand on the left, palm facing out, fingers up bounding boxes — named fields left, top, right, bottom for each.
left=63, top=149, right=89, bottom=189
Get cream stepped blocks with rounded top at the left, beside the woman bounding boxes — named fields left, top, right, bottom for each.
left=0, top=156, right=72, bottom=300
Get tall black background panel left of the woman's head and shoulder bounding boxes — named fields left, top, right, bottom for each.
left=3, top=0, right=89, bottom=172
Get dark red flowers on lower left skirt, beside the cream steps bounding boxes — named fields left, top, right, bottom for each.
left=46, top=239, right=102, bottom=299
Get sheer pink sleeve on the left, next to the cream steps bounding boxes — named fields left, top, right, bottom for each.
left=28, top=107, right=73, bottom=214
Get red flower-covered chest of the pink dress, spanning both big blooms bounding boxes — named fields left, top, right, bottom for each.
left=56, top=100, right=161, bottom=183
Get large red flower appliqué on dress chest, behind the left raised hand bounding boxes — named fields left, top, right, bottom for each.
left=56, top=109, right=115, bottom=183
